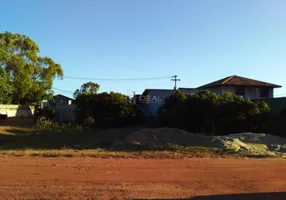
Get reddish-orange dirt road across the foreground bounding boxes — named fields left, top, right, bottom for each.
left=0, top=157, right=286, bottom=200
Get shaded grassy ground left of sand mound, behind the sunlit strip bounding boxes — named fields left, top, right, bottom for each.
left=0, top=120, right=146, bottom=150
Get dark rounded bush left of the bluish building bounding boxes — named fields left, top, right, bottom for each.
left=75, top=88, right=136, bottom=127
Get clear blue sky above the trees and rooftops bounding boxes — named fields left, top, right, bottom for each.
left=0, top=0, right=286, bottom=96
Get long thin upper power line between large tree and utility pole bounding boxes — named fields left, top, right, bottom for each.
left=64, top=76, right=172, bottom=81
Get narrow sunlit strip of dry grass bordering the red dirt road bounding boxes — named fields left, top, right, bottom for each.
left=0, top=147, right=280, bottom=159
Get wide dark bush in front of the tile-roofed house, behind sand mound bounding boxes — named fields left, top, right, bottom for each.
left=159, top=91, right=270, bottom=134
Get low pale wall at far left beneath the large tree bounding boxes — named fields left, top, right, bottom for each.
left=0, top=104, right=34, bottom=117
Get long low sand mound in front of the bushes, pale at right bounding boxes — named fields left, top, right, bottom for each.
left=114, top=128, right=286, bottom=155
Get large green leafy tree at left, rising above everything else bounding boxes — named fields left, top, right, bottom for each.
left=0, top=32, right=63, bottom=104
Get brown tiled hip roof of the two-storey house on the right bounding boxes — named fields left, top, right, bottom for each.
left=198, top=75, right=282, bottom=88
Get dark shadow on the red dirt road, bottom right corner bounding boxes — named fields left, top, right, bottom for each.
left=134, top=192, right=286, bottom=200
